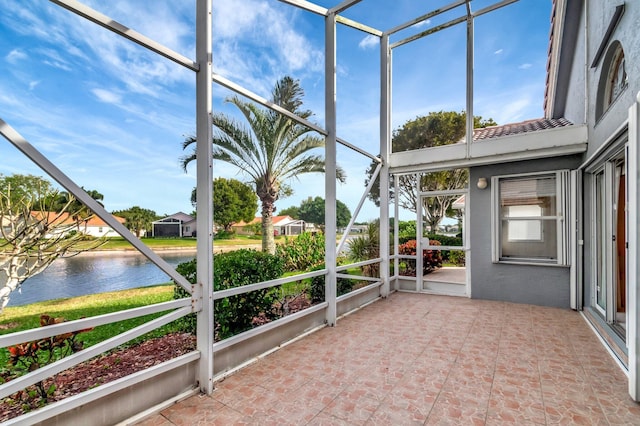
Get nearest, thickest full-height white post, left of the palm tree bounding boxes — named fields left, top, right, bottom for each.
left=192, top=0, right=213, bottom=395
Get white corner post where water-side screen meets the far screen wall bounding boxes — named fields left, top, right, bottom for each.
left=379, top=34, right=390, bottom=297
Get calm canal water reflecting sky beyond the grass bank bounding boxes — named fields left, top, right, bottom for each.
left=8, top=252, right=195, bottom=306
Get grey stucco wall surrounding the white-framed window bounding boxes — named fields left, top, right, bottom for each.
left=468, top=155, right=582, bottom=308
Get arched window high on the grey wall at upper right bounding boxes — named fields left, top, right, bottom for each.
left=596, top=41, right=627, bottom=120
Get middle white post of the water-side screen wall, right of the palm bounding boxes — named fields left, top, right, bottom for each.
left=324, top=13, right=337, bottom=326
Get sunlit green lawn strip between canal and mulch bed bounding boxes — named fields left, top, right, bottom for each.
left=0, top=285, right=175, bottom=365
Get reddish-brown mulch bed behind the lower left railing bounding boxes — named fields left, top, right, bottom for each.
left=0, top=333, right=196, bottom=422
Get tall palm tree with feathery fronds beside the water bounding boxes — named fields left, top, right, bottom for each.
left=181, top=77, right=344, bottom=253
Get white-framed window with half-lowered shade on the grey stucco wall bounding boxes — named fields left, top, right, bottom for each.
left=492, top=171, right=568, bottom=265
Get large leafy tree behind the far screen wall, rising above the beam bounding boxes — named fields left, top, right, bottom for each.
left=365, top=111, right=496, bottom=231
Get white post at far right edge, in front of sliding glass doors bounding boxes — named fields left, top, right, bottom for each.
left=627, top=93, right=640, bottom=401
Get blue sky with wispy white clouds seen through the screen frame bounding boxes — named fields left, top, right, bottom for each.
left=0, top=0, right=551, bottom=221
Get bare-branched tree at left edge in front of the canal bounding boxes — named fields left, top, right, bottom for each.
left=0, top=175, right=104, bottom=313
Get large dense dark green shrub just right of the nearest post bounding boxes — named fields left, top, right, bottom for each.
left=174, top=249, right=284, bottom=340
